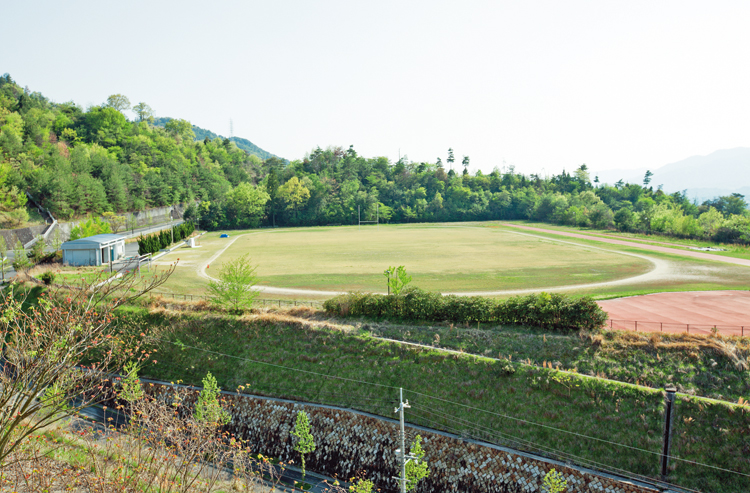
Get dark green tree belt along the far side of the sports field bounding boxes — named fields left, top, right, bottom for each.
left=191, top=147, right=750, bottom=242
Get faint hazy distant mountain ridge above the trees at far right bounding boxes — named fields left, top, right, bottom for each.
left=591, top=147, right=750, bottom=202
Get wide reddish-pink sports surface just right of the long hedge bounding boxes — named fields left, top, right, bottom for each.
left=598, top=291, right=750, bottom=336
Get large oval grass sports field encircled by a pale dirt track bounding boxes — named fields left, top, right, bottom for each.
left=158, top=223, right=680, bottom=294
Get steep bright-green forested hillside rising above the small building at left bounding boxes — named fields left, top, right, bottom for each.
left=0, top=74, right=262, bottom=227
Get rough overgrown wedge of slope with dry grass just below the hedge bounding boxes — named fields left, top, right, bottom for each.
left=370, top=323, right=750, bottom=402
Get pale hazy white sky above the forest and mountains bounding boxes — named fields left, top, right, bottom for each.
left=0, top=0, right=750, bottom=174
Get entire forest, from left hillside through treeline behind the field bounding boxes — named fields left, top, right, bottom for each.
left=0, top=74, right=750, bottom=243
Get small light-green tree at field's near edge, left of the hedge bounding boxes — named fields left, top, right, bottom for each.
left=208, top=254, right=258, bottom=312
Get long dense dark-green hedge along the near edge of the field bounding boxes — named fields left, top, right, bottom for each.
left=323, top=288, right=607, bottom=331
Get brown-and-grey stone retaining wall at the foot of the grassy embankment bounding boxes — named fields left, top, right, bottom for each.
left=146, top=384, right=657, bottom=493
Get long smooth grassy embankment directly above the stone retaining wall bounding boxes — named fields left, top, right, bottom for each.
left=131, top=309, right=750, bottom=492
